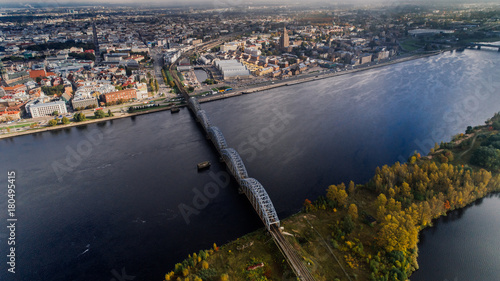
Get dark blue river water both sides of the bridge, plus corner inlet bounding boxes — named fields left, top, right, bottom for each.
left=0, top=49, right=500, bottom=281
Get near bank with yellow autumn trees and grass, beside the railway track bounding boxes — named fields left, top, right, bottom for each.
left=165, top=114, right=500, bottom=281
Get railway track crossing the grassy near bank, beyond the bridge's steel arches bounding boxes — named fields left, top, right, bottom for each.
left=269, top=225, right=315, bottom=281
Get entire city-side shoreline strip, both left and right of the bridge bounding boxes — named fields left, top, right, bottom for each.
left=0, top=51, right=444, bottom=139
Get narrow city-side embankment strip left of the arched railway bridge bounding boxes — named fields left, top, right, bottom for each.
left=0, top=105, right=185, bottom=139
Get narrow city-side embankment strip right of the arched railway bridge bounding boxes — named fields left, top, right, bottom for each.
left=198, top=51, right=443, bottom=103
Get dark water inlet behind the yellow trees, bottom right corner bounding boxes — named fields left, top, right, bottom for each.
left=410, top=193, right=500, bottom=281
